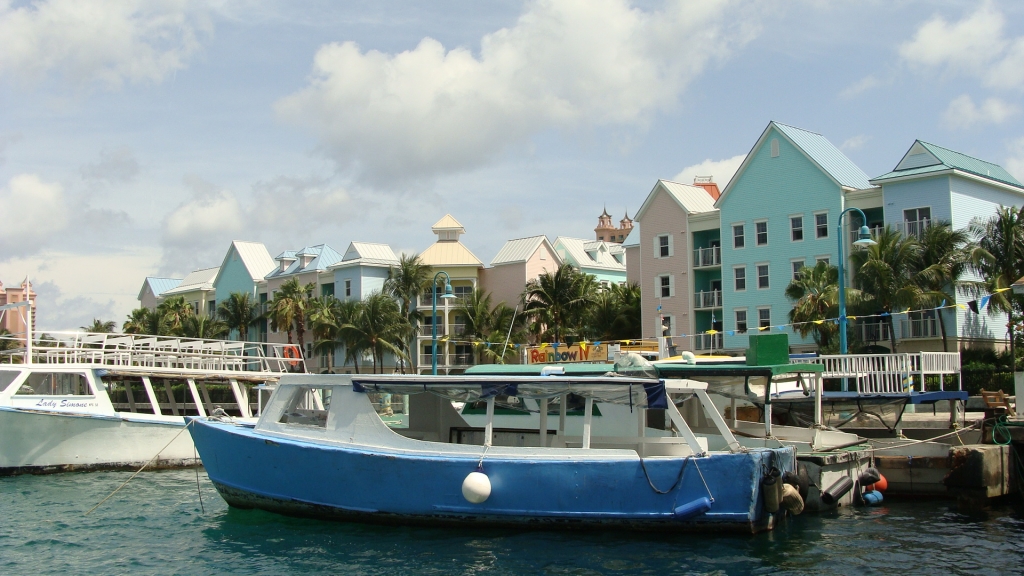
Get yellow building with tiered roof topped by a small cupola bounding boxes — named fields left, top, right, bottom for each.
left=416, top=214, right=483, bottom=374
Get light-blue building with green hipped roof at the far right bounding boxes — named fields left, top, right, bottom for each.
left=866, top=140, right=1024, bottom=351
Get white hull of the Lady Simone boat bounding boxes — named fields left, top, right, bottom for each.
left=0, top=407, right=200, bottom=476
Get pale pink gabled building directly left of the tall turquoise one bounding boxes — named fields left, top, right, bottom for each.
left=626, top=180, right=722, bottom=344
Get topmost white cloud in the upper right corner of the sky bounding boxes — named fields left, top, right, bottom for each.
left=899, top=2, right=1006, bottom=72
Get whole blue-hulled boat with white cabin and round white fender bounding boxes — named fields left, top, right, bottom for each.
left=188, top=375, right=796, bottom=532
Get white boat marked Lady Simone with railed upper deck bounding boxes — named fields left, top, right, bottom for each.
left=0, top=317, right=305, bottom=476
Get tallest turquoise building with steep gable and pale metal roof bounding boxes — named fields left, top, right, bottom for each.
left=715, top=122, right=883, bottom=349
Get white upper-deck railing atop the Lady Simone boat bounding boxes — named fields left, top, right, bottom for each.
left=0, top=332, right=306, bottom=373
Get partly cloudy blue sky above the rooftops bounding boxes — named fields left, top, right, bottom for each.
left=0, top=0, right=1024, bottom=330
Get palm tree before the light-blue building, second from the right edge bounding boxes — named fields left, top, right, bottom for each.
left=916, top=221, right=980, bottom=352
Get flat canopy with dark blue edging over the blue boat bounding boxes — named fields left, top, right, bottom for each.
left=352, top=375, right=668, bottom=409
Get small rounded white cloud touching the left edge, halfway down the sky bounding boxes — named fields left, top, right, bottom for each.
left=0, top=174, right=69, bottom=256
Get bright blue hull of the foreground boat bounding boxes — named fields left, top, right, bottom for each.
left=188, top=419, right=796, bottom=532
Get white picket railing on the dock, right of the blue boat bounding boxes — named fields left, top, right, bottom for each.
left=793, top=352, right=961, bottom=394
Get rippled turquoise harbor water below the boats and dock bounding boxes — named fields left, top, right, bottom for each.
left=0, top=469, right=1024, bottom=576
